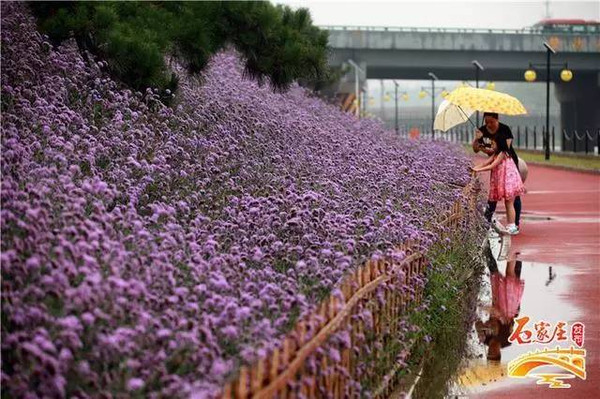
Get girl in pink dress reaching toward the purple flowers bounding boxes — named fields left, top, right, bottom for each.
left=473, top=140, right=525, bottom=234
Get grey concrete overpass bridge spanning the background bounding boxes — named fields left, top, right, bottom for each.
left=321, top=26, right=600, bottom=130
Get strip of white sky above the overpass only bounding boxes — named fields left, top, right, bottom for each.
left=274, top=0, right=600, bottom=29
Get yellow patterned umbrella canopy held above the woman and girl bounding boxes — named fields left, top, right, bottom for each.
left=446, top=87, right=527, bottom=115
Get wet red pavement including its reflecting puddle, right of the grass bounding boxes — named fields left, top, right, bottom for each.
left=451, top=166, right=600, bottom=399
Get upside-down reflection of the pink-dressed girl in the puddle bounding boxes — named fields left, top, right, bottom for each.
left=475, top=260, right=525, bottom=361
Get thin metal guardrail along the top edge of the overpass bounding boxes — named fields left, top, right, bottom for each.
left=318, top=25, right=600, bottom=36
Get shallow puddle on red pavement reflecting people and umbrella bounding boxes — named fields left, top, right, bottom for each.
left=449, top=234, right=582, bottom=397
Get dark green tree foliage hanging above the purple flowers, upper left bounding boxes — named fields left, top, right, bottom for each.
left=30, top=1, right=333, bottom=98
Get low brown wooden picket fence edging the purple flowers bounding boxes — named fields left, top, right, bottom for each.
left=221, top=180, right=478, bottom=399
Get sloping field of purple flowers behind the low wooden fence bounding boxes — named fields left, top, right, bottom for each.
left=1, top=3, right=469, bottom=397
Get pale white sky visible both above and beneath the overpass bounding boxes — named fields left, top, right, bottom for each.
left=272, top=0, right=600, bottom=117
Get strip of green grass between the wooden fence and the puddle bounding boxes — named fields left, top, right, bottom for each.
left=399, top=223, right=485, bottom=398
